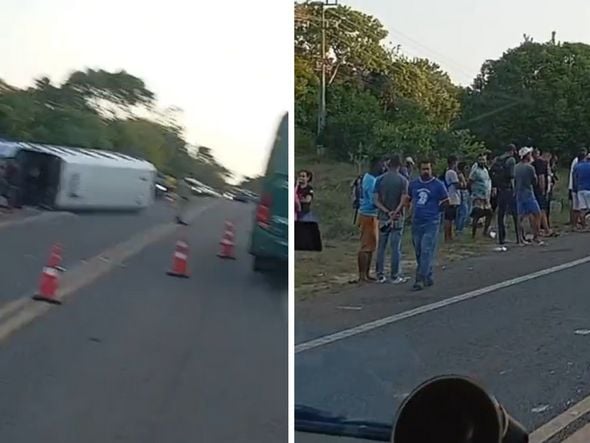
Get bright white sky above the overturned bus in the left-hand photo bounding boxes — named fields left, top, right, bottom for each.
left=0, top=0, right=293, bottom=180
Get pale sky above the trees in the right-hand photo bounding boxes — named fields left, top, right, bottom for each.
left=340, top=0, right=590, bottom=85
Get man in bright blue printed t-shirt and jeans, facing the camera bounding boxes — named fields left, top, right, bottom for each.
left=408, top=160, right=449, bottom=291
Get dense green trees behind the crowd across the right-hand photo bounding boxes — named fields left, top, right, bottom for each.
left=295, top=4, right=590, bottom=166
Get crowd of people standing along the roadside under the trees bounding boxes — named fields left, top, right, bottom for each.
left=353, top=144, right=590, bottom=290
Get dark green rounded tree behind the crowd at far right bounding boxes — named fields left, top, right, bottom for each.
left=461, top=40, right=590, bottom=159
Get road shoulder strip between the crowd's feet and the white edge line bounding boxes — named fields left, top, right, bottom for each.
left=295, top=233, right=590, bottom=342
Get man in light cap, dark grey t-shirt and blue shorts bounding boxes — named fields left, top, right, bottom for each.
left=514, top=146, right=541, bottom=244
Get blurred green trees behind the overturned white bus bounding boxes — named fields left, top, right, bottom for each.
left=0, top=69, right=236, bottom=188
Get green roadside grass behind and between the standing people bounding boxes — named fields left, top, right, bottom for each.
left=295, top=156, right=569, bottom=300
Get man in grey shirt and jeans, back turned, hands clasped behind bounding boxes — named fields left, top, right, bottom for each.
left=374, top=155, right=408, bottom=284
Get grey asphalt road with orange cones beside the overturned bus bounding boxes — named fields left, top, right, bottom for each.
left=0, top=202, right=288, bottom=443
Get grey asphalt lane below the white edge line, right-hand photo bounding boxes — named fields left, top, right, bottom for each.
left=295, top=258, right=590, bottom=443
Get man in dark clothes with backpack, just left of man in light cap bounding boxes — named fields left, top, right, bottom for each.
left=490, top=144, right=520, bottom=245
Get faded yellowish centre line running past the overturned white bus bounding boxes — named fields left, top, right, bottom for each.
left=0, top=200, right=220, bottom=341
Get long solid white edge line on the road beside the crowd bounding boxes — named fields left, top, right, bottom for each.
left=295, top=256, right=590, bottom=354
